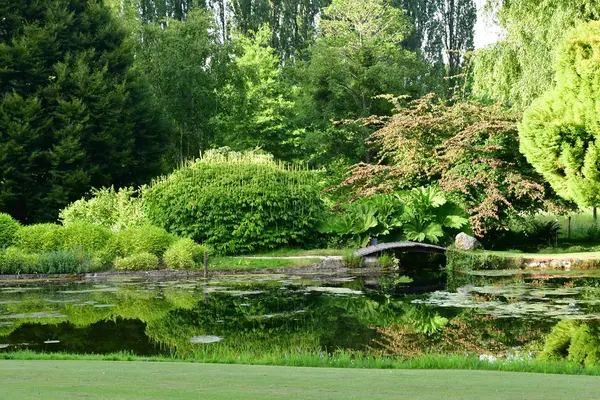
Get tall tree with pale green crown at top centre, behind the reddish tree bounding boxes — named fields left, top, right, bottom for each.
left=299, top=0, right=427, bottom=161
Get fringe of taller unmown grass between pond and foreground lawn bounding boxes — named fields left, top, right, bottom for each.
left=0, top=350, right=600, bottom=376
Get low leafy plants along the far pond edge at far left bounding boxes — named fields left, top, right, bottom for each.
left=0, top=247, right=93, bottom=274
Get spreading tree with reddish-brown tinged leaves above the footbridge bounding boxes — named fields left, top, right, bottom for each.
left=342, top=96, right=568, bottom=236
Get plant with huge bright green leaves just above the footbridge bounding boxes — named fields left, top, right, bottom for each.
left=403, top=186, right=468, bottom=243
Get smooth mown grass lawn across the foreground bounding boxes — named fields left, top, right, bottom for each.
left=0, top=360, right=600, bottom=400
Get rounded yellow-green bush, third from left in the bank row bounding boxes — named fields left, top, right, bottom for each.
left=62, top=222, right=112, bottom=253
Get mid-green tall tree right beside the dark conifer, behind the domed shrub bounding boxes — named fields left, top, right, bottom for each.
left=138, top=9, right=229, bottom=160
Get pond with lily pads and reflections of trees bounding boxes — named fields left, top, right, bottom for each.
left=0, top=271, right=600, bottom=358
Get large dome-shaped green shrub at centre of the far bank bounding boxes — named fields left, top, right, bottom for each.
left=144, top=155, right=324, bottom=253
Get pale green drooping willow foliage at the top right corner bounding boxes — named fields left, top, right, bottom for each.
left=473, top=0, right=600, bottom=109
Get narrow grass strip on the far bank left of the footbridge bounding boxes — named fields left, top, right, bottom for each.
left=208, top=257, right=321, bottom=271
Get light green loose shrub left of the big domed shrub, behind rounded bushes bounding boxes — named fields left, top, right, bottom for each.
left=59, top=186, right=147, bottom=232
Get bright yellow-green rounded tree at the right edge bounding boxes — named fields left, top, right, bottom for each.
left=519, top=22, right=600, bottom=207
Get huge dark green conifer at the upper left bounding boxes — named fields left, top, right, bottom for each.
left=0, top=0, right=168, bottom=222
